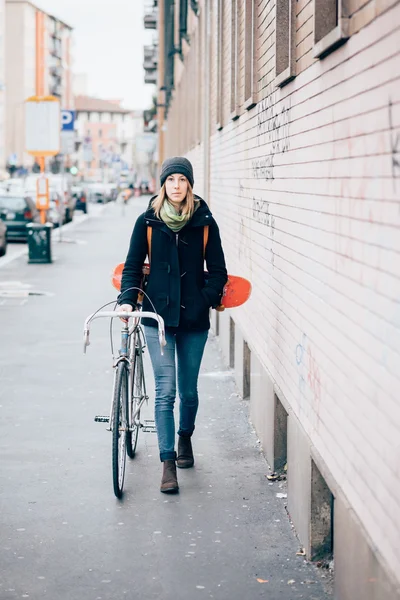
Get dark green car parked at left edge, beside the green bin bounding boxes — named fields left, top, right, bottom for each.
left=0, top=191, right=40, bottom=241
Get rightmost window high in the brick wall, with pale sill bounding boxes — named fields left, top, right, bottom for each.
left=313, top=0, right=349, bottom=58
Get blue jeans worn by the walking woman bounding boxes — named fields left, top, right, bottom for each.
left=144, top=327, right=208, bottom=461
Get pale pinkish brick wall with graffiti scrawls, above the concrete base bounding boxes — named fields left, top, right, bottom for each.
left=162, top=0, right=400, bottom=584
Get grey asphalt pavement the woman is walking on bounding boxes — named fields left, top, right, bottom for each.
left=0, top=199, right=330, bottom=600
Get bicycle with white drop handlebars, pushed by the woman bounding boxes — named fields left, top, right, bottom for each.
left=83, top=311, right=166, bottom=498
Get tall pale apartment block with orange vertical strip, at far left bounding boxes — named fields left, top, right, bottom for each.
left=5, top=0, right=73, bottom=167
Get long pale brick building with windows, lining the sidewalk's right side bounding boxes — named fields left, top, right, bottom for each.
left=155, top=0, right=400, bottom=600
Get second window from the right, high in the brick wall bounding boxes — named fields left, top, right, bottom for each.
left=275, top=0, right=296, bottom=86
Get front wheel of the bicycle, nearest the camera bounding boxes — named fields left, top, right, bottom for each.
left=112, top=361, right=128, bottom=498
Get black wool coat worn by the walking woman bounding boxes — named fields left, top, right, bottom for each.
left=118, top=196, right=227, bottom=331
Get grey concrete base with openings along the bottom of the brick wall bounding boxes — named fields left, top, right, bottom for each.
left=211, top=311, right=400, bottom=600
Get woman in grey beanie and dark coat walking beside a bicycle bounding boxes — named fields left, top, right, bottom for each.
left=118, top=156, right=227, bottom=493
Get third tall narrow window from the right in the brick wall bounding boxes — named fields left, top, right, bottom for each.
left=244, top=0, right=257, bottom=110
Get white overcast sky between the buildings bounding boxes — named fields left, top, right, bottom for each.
left=33, top=0, right=155, bottom=109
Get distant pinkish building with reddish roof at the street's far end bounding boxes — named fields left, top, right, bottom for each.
left=72, top=96, right=143, bottom=181
